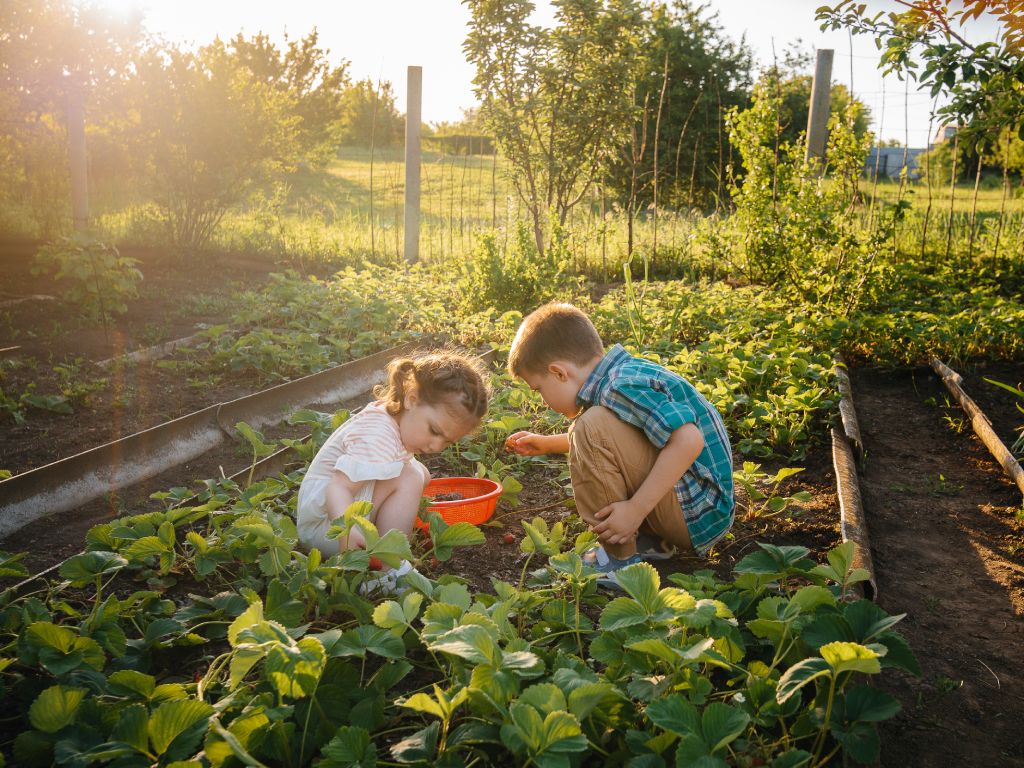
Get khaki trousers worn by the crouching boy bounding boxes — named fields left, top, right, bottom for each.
left=569, top=406, right=693, bottom=559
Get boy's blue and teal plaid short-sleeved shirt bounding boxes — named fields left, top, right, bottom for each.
left=577, top=344, right=734, bottom=555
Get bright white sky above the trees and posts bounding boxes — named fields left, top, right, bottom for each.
left=117, top=0, right=996, bottom=146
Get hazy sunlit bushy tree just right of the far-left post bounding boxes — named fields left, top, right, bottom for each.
left=125, top=40, right=299, bottom=251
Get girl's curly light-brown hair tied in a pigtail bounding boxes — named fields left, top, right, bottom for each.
left=374, top=349, right=490, bottom=421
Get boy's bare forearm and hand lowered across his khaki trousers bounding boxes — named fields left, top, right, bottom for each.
left=594, top=423, right=705, bottom=544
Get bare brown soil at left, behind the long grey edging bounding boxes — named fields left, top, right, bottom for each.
left=0, top=243, right=280, bottom=474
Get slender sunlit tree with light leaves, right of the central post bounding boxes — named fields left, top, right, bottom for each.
left=464, top=0, right=643, bottom=253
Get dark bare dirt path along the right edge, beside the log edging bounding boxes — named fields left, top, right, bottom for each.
left=853, top=366, right=1024, bottom=768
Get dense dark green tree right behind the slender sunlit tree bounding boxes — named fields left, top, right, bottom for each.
left=606, top=0, right=751, bottom=220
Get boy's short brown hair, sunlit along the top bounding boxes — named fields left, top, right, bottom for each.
left=508, top=301, right=604, bottom=378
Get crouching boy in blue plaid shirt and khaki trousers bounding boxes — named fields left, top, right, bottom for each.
left=506, top=303, right=733, bottom=586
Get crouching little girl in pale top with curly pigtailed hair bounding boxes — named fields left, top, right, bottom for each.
left=297, top=351, right=489, bottom=572
